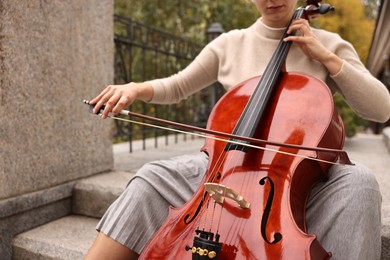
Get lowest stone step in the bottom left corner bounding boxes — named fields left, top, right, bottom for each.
left=12, top=215, right=98, bottom=260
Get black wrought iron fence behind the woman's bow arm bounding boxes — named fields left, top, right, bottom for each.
left=113, top=15, right=223, bottom=152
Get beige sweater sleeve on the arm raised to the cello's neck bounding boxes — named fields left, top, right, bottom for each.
left=330, top=34, right=390, bottom=122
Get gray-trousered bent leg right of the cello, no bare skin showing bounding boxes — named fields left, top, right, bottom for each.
left=306, top=161, right=381, bottom=260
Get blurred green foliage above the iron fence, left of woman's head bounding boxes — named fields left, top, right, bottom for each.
left=115, top=0, right=259, bottom=43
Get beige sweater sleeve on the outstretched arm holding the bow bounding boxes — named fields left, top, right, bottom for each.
left=148, top=43, right=219, bottom=104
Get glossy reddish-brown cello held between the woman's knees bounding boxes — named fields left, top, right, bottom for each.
left=140, top=0, right=345, bottom=259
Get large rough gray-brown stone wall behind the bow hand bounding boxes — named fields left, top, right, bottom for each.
left=0, top=0, right=114, bottom=199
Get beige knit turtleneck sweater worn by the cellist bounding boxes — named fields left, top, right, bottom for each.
left=149, top=18, right=390, bottom=122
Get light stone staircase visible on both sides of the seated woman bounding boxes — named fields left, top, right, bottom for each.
left=12, top=131, right=390, bottom=260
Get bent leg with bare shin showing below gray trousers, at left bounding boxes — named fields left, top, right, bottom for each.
left=85, top=154, right=207, bottom=255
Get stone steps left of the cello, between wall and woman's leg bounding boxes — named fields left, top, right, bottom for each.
left=12, top=137, right=204, bottom=260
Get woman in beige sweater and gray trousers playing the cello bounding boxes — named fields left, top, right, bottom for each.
left=86, top=0, right=390, bottom=259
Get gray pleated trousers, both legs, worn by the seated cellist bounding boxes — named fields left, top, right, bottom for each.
left=97, top=154, right=381, bottom=260
